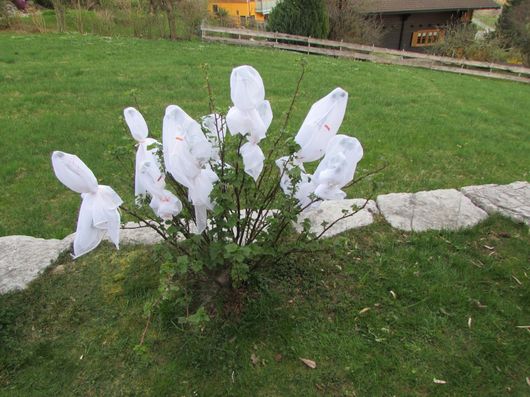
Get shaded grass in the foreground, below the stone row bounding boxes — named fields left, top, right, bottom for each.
left=0, top=218, right=530, bottom=397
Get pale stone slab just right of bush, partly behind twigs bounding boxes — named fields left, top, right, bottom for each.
left=296, top=199, right=379, bottom=237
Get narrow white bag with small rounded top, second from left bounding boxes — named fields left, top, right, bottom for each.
left=123, top=107, right=160, bottom=198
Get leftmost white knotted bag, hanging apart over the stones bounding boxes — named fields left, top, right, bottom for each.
left=52, top=151, right=123, bottom=258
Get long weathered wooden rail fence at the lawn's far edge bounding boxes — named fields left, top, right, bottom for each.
left=201, top=25, right=530, bottom=83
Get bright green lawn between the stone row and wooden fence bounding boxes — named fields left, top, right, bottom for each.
left=0, top=33, right=530, bottom=238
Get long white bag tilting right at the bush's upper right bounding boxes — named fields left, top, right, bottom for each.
left=295, top=88, right=348, bottom=163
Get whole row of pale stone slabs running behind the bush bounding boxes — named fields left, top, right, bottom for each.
left=0, top=182, right=530, bottom=294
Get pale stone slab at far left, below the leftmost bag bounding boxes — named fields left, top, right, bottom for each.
left=0, top=236, right=70, bottom=294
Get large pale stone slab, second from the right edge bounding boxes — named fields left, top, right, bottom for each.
left=377, top=189, right=488, bottom=232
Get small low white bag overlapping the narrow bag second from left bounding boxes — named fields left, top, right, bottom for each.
left=140, top=161, right=182, bottom=219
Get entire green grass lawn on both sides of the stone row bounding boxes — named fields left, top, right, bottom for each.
left=0, top=33, right=530, bottom=397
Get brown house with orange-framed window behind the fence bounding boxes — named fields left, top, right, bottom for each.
left=363, top=0, right=500, bottom=51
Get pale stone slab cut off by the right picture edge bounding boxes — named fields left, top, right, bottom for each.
left=461, top=182, right=530, bottom=226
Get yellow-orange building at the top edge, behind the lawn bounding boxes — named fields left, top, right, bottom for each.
left=208, top=0, right=277, bottom=25
